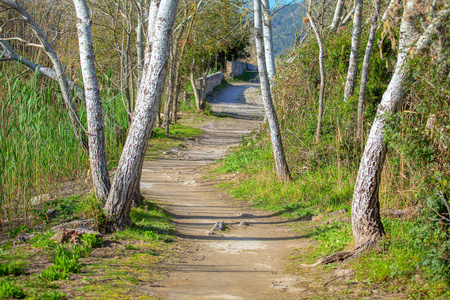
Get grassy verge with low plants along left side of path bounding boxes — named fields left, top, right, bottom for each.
left=0, top=114, right=202, bottom=299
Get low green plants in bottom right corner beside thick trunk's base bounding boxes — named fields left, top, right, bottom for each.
left=355, top=218, right=450, bottom=298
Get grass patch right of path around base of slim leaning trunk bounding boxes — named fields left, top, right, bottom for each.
left=216, top=143, right=353, bottom=218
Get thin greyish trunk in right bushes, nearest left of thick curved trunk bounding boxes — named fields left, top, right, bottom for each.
left=356, top=0, right=380, bottom=141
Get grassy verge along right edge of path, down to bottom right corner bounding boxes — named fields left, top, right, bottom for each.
left=208, top=140, right=450, bottom=299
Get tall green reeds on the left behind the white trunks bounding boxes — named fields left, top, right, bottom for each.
left=0, top=66, right=128, bottom=230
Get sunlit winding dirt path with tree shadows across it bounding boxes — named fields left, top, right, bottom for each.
left=141, top=84, right=308, bottom=299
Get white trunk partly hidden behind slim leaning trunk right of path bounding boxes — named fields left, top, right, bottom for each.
left=261, top=0, right=277, bottom=82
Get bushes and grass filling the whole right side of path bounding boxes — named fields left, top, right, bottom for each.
left=217, top=0, right=450, bottom=297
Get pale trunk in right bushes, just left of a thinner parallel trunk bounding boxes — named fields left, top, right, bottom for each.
left=344, top=0, right=363, bottom=102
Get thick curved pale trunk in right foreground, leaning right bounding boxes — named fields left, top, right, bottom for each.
left=352, top=0, right=417, bottom=249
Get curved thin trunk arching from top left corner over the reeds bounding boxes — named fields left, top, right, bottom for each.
left=0, top=0, right=89, bottom=153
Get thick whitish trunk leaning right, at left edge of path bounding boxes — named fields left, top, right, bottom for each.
left=104, top=0, right=178, bottom=229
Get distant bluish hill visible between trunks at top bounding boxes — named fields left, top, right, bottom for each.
left=272, top=3, right=306, bottom=55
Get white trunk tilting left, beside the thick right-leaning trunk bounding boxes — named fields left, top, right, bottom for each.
left=73, top=0, right=111, bottom=204
